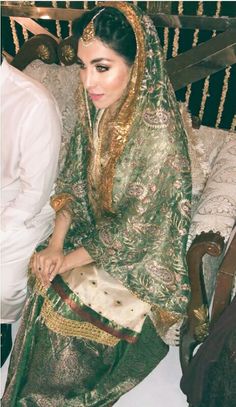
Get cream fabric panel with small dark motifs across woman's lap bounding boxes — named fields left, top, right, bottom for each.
left=62, top=263, right=151, bottom=332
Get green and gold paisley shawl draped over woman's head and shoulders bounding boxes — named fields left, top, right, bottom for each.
left=52, top=2, right=191, bottom=331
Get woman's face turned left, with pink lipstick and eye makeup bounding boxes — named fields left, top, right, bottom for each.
left=78, top=38, right=131, bottom=109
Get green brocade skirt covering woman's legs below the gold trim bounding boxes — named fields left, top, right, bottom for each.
left=2, top=278, right=168, bottom=407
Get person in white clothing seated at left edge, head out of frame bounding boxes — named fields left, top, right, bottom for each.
left=0, top=56, right=61, bottom=366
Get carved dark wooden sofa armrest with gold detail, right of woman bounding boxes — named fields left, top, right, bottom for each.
left=180, top=231, right=224, bottom=371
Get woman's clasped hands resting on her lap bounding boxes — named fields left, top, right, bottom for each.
left=31, top=245, right=65, bottom=288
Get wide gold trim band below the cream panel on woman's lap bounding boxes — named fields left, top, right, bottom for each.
left=41, top=298, right=120, bottom=346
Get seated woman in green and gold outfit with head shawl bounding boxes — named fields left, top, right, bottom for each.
left=3, top=2, right=191, bottom=407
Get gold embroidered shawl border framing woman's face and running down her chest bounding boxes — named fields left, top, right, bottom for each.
left=85, top=2, right=146, bottom=212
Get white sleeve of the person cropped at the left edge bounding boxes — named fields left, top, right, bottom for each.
left=1, top=97, right=62, bottom=230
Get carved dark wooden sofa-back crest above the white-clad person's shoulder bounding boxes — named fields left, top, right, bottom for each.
left=11, top=34, right=59, bottom=71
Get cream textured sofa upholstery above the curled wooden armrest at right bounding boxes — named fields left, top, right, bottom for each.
left=189, top=134, right=236, bottom=247
